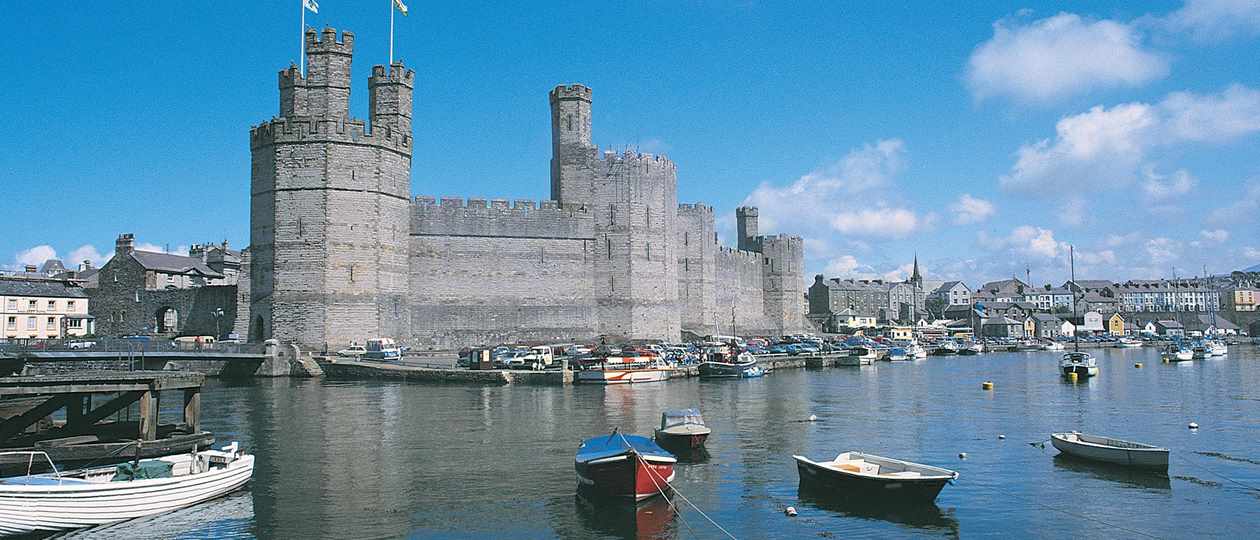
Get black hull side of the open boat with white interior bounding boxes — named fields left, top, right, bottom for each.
left=796, top=459, right=949, bottom=503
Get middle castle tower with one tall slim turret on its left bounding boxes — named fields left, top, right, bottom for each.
left=548, top=84, right=680, bottom=340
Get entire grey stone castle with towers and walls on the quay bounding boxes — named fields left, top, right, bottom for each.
left=249, top=29, right=805, bottom=349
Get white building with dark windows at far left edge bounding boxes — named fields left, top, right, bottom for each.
left=0, top=276, right=95, bottom=340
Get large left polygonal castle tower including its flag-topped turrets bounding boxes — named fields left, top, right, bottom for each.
left=249, top=29, right=415, bottom=350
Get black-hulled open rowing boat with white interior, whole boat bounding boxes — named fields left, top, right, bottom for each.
left=793, top=452, right=958, bottom=503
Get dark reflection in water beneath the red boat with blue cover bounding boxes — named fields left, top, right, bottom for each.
left=573, top=488, right=678, bottom=539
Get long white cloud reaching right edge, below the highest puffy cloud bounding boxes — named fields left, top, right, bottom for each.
left=1000, top=84, right=1260, bottom=193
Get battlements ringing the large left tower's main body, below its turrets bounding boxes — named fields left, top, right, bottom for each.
left=249, top=117, right=412, bottom=155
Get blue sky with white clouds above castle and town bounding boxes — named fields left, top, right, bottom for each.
left=0, top=0, right=1260, bottom=286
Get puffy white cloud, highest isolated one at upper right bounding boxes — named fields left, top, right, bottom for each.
left=966, top=13, right=1168, bottom=102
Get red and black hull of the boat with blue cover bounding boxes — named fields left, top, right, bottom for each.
left=573, top=452, right=674, bottom=501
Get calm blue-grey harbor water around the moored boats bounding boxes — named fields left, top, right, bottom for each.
left=132, top=345, right=1260, bottom=539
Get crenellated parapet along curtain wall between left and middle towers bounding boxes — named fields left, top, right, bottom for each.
left=411, top=196, right=595, bottom=239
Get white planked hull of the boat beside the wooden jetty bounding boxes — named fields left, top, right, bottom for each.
left=0, top=454, right=253, bottom=536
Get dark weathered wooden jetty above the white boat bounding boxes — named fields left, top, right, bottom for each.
left=0, top=371, right=214, bottom=475
